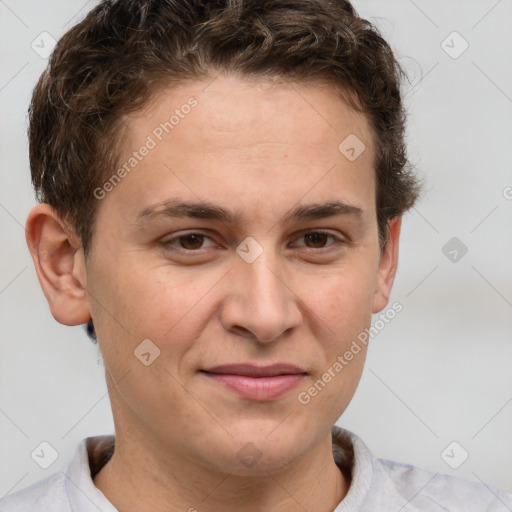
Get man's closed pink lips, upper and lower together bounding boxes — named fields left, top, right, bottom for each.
left=202, top=364, right=307, bottom=401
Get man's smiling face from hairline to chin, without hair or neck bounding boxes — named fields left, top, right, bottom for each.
left=70, top=76, right=398, bottom=472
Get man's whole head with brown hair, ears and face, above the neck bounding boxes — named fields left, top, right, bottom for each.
left=27, top=0, right=419, bottom=476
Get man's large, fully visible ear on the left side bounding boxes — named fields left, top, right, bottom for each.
left=25, top=203, right=91, bottom=325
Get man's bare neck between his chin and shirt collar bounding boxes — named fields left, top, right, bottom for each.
left=94, top=434, right=349, bottom=512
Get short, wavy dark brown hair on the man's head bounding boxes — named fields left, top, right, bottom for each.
left=29, top=0, right=420, bottom=344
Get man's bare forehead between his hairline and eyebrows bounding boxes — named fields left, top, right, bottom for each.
left=104, top=75, right=375, bottom=227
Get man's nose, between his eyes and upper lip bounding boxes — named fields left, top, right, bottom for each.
left=220, top=246, right=302, bottom=343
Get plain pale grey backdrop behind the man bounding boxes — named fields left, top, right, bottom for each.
left=0, top=0, right=512, bottom=495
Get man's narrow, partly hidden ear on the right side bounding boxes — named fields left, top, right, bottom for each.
left=373, top=216, right=402, bottom=313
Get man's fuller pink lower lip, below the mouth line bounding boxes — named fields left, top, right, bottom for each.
left=204, top=372, right=305, bottom=401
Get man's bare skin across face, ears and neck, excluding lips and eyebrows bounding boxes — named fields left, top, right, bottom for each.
left=27, top=75, right=400, bottom=512
